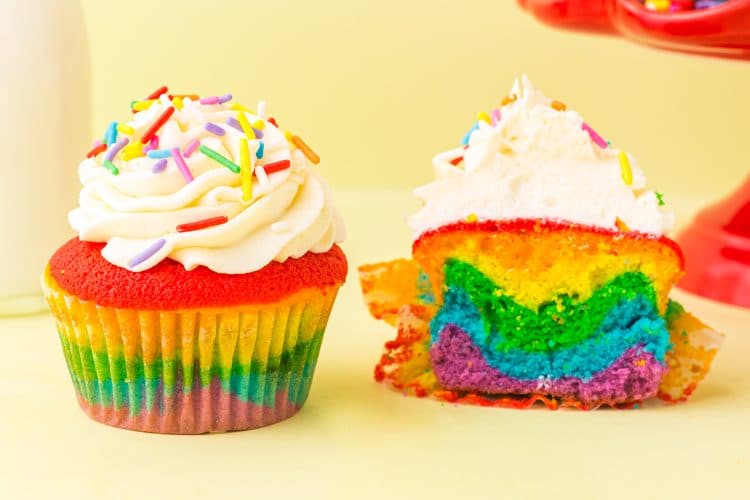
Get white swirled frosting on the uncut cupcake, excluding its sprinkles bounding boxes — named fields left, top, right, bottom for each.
left=68, top=96, right=344, bottom=274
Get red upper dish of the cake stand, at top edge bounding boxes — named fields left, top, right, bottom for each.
left=518, top=0, right=750, bottom=60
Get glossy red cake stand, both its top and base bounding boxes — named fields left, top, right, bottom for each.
left=518, top=0, right=750, bottom=308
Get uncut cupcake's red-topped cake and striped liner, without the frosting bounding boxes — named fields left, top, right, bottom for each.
left=44, top=239, right=346, bottom=434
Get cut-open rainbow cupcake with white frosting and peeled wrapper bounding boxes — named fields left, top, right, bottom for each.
left=360, top=77, right=722, bottom=409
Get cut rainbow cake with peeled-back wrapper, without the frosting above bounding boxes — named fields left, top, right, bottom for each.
left=361, top=220, right=719, bottom=408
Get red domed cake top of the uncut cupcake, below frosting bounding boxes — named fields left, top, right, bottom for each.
left=49, top=238, right=347, bottom=310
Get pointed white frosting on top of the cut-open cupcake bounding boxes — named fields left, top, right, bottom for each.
left=408, top=76, right=674, bottom=239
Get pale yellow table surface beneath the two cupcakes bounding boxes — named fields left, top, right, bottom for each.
left=0, top=189, right=750, bottom=499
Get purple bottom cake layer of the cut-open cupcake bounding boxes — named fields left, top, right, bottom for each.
left=430, top=324, right=666, bottom=406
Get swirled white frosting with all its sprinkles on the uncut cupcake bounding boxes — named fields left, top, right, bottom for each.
left=68, top=88, right=344, bottom=274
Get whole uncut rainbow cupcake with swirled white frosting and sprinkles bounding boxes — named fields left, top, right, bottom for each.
left=42, top=87, right=347, bottom=434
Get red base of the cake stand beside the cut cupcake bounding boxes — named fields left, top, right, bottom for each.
left=677, top=177, right=750, bottom=307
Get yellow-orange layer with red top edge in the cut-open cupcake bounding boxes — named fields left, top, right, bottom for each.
left=413, top=221, right=683, bottom=314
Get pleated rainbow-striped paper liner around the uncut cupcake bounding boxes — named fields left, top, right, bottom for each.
left=43, top=274, right=338, bottom=434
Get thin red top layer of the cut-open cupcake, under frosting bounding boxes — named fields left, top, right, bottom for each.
left=412, top=219, right=685, bottom=269
